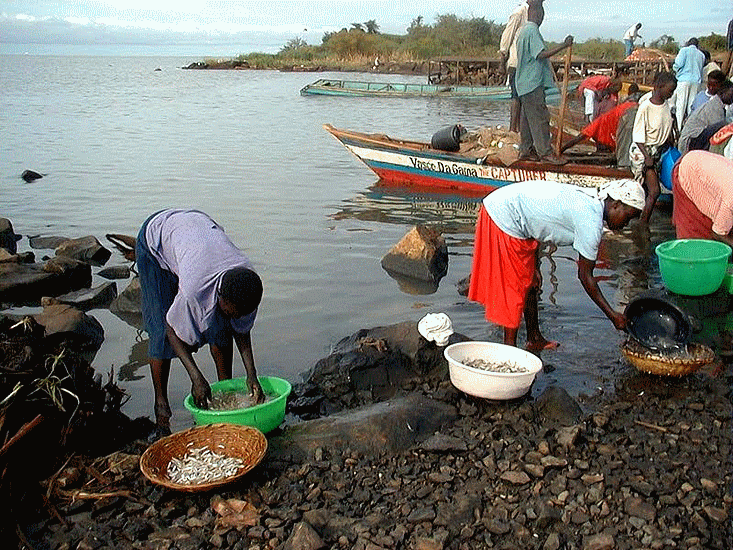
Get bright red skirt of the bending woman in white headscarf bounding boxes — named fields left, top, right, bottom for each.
left=468, top=205, right=538, bottom=328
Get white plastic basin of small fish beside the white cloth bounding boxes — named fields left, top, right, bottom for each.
left=443, top=342, right=542, bottom=400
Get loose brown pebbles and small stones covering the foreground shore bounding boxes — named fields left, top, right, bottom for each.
left=20, top=328, right=733, bottom=550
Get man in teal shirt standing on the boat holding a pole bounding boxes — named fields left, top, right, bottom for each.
left=515, top=0, right=573, bottom=164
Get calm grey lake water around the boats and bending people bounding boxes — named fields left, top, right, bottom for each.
left=0, top=55, right=671, bottom=432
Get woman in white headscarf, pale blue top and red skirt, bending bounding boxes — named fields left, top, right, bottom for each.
left=468, top=180, right=646, bottom=351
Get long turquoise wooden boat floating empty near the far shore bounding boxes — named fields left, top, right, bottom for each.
left=300, top=78, right=577, bottom=101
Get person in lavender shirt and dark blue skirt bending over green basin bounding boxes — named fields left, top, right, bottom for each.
left=135, top=209, right=264, bottom=436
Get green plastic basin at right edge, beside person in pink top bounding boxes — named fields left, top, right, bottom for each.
left=656, top=239, right=731, bottom=296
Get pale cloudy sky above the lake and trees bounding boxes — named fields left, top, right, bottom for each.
left=0, top=0, right=733, bottom=53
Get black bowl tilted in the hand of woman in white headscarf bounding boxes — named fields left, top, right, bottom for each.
left=624, top=296, right=692, bottom=351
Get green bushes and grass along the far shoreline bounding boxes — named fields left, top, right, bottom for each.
left=207, top=14, right=725, bottom=69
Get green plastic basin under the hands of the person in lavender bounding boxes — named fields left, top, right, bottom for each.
left=183, top=376, right=292, bottom=433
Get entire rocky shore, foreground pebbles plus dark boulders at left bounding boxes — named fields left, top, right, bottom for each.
left=0, top=221, right=733, bottom=550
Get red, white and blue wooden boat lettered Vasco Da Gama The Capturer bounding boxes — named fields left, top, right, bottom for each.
left=324, top=124, right=632, bottom=195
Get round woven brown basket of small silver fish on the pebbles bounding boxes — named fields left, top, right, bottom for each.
left=140, top=424, right=267, bottom=492
